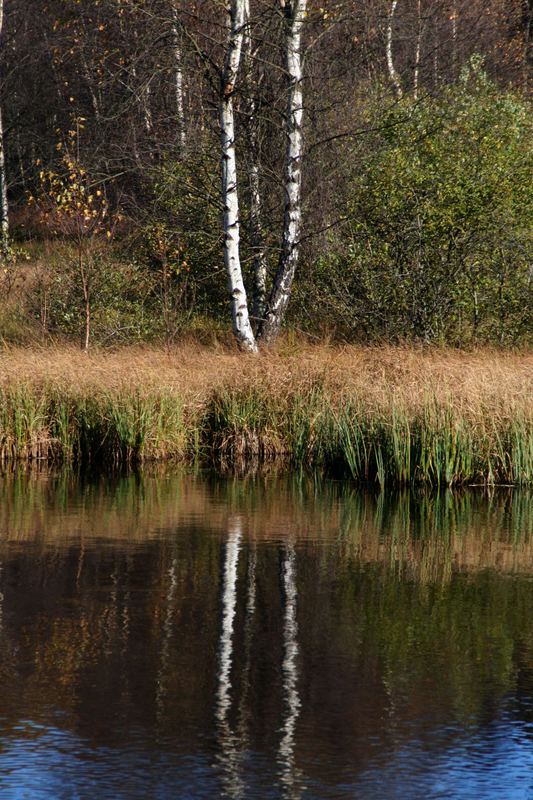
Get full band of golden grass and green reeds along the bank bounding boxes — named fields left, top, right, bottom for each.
left=0, top=343, right=533, bottom=487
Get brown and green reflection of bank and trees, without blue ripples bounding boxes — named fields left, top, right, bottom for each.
left=0, top=475, right=533, bottom=784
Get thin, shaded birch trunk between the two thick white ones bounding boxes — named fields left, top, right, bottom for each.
left=244, top=0, right=267, bottom=322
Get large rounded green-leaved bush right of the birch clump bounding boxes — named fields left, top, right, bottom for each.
left=313, top=60, right=533, bottom=344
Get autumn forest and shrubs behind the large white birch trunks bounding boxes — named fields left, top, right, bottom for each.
left=0, top=0, right=533, bottom=348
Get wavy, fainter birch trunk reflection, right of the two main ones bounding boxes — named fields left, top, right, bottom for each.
left=278, top=543, right=302, bottom=800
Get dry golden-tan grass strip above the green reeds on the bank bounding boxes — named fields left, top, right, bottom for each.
left=0, top=344, right=533, bottom=418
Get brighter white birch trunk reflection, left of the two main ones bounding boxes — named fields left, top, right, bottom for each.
left=215, top=518, right=244, bottom=798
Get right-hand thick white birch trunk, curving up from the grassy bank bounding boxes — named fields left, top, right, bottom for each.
left=260, top=0, right=307, bottom=346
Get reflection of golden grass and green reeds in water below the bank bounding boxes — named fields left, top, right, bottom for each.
left=0, top=470, right=533, bottom=582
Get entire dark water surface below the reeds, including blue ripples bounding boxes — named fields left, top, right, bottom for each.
left=0, top=474, right=533, bottom=800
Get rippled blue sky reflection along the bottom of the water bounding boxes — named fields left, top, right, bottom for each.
left=0, top=714, right=533, bottom=800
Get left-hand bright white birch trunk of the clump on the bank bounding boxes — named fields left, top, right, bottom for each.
left=220, top=0, right=257, bottom=353
